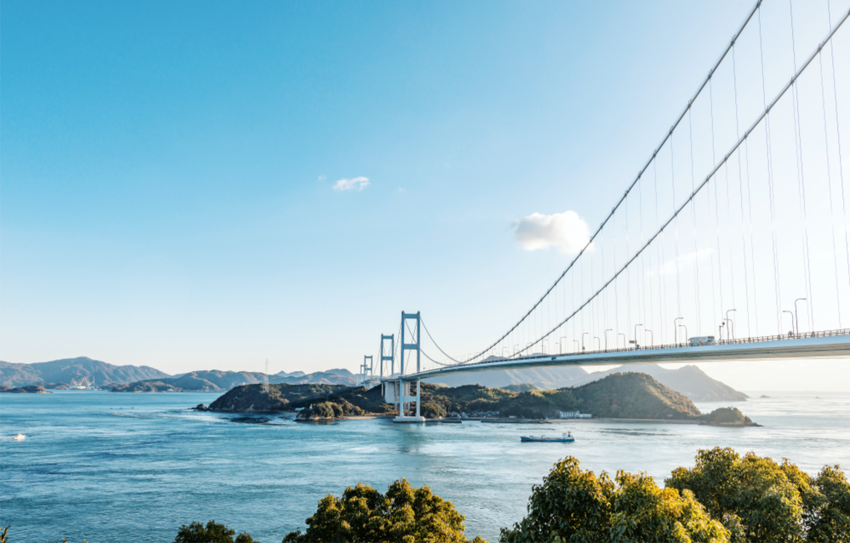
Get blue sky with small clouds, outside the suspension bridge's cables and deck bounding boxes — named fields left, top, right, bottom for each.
left=0, top=0, right=850, bottom=390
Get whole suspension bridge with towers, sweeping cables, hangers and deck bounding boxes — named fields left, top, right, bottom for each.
left=360, top=0, right=850, bottom=422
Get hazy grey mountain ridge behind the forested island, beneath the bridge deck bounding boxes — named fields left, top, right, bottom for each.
left=427, top=364, right=748, bottom=402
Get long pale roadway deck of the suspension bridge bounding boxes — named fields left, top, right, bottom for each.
left=396, top=330, right=850, bottom=381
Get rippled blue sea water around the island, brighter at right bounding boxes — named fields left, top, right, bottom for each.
left=0, top=392, right=850, bottom=543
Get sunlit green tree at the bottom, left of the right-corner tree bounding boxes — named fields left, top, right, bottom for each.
left=500, top=457, right=728, bottom=543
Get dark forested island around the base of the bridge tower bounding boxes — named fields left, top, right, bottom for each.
left=203, top=372, right=755, bottom=426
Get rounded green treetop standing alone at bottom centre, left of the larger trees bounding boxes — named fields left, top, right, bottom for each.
left=283, top=479, right=486, bottom=543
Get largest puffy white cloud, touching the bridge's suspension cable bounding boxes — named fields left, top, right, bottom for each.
left=514, top=211, right=590, bottom=255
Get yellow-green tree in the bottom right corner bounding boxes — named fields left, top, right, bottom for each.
left=667, top=447, right=850, bottom=543
